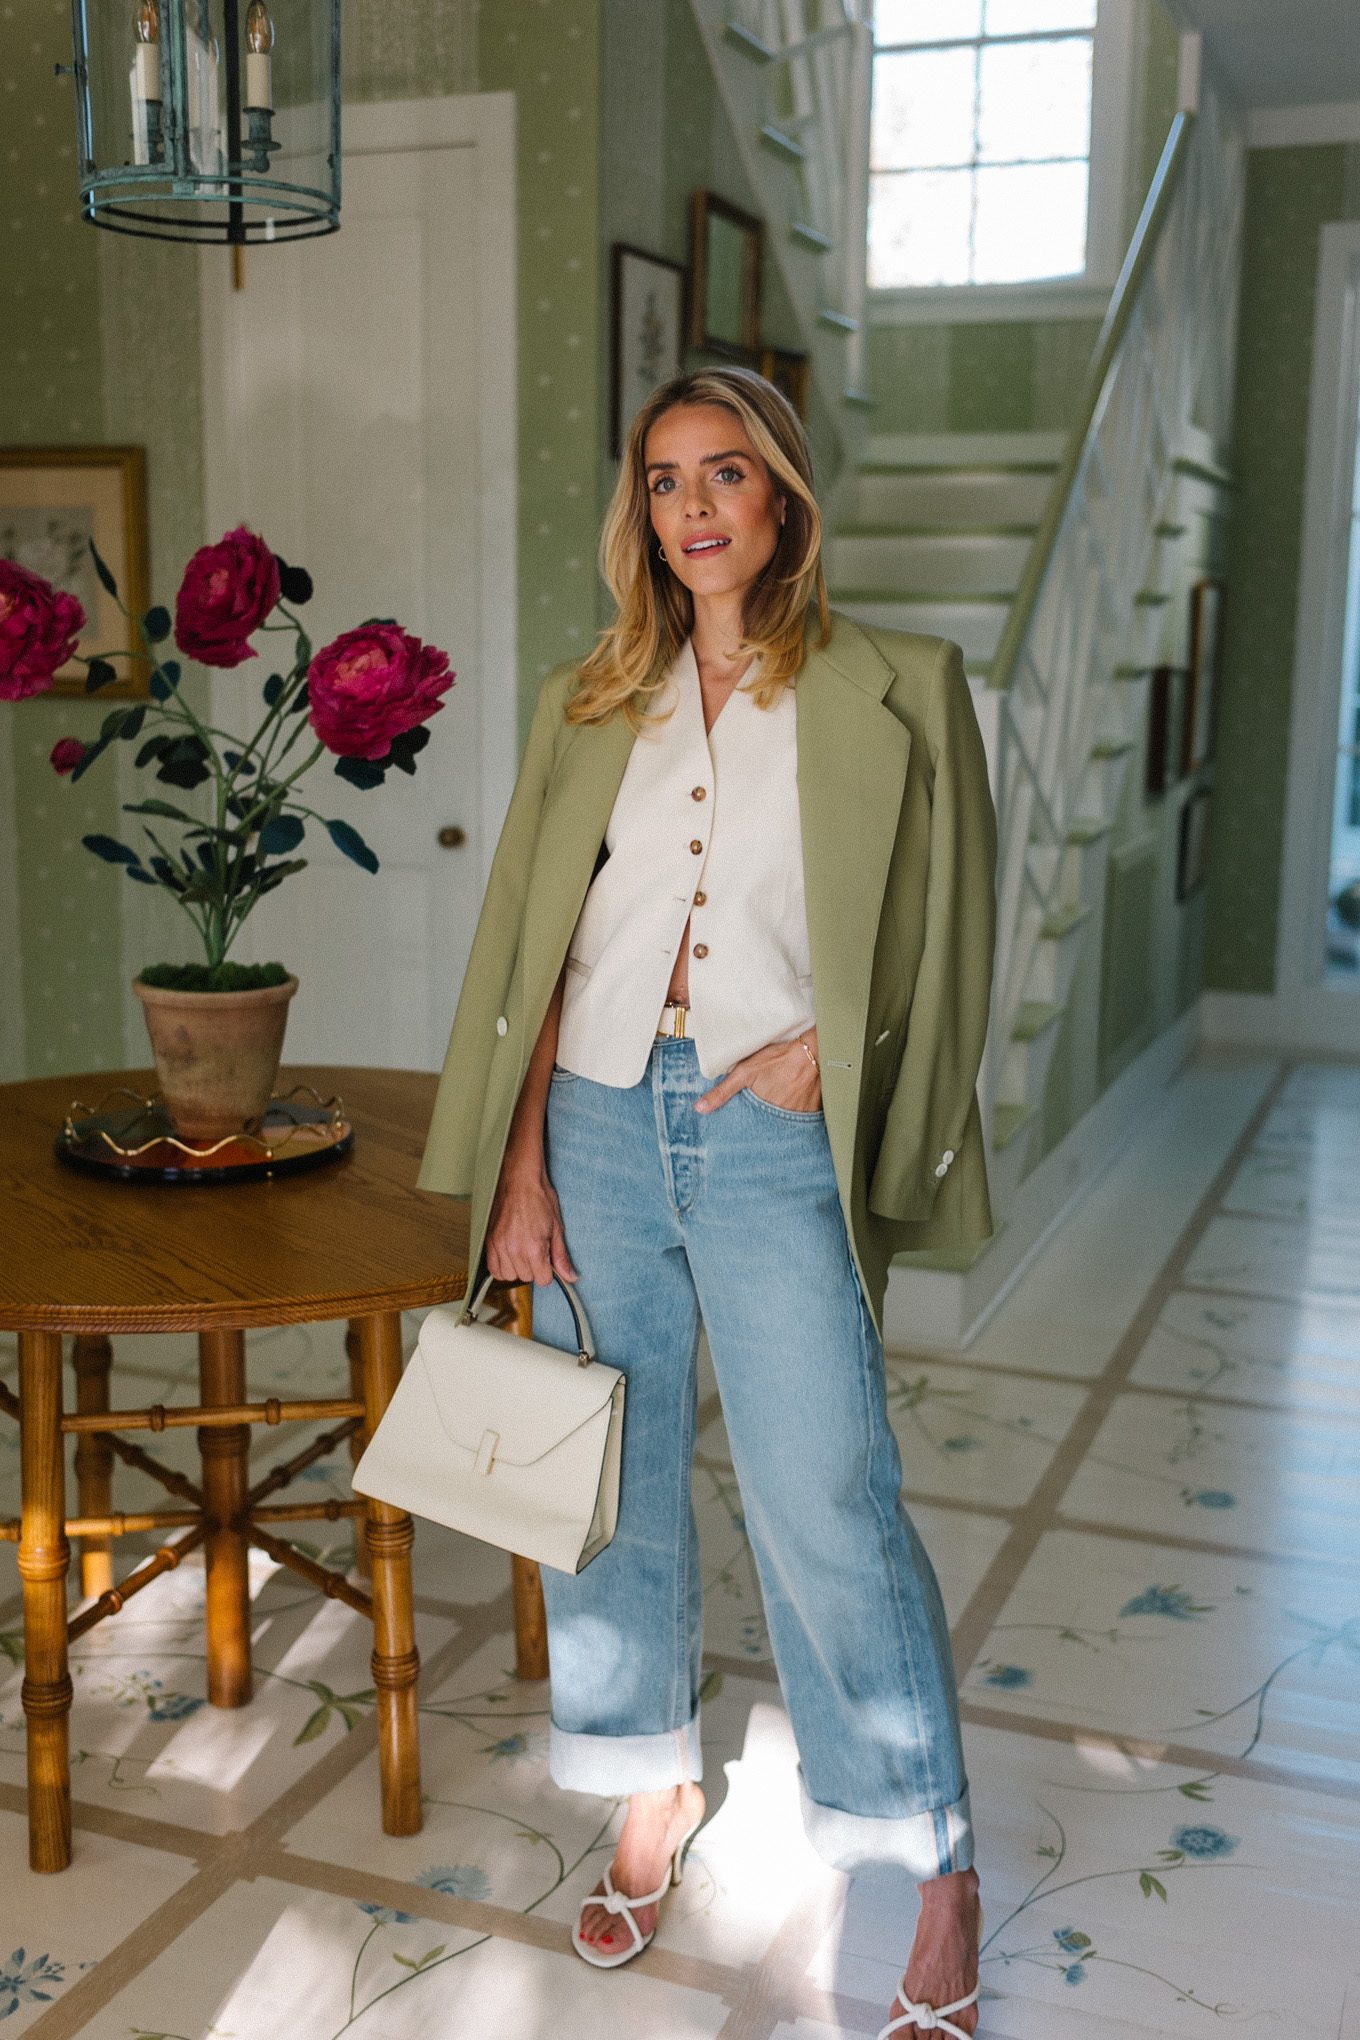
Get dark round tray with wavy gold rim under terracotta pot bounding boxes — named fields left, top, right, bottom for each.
left=53, top=1083, right=355, bottom=1183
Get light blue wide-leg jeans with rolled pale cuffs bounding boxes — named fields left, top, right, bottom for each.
left=534, top=1038, right=973, bottom=1879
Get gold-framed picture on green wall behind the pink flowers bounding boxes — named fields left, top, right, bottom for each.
left=0, top=447, right=151, bottom=702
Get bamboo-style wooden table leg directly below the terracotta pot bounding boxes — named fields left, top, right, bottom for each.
left=198, top=1330, right=251, bottom=1707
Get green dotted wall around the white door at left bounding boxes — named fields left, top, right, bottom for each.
left=0, top=0, right=601, bottom=1075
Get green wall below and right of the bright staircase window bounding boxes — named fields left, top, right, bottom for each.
left=867, top=0, right=1179, bottom=432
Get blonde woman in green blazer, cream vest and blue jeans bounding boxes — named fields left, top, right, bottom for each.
left=420, top=367, right=995, bottom=2036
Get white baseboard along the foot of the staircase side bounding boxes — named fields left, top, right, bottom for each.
left=883, top=1006, right=1201, bottom=1353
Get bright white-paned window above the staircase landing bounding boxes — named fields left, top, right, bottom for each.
left=869, top=0, right=1097, bottom=290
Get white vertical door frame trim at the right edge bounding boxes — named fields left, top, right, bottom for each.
left=1274, top=220, right=1360, bottom=1016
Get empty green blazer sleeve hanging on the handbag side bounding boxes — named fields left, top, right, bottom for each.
left=416, top=667, right=573, bottom=1197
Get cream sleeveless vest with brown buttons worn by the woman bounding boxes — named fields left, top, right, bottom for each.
left=557, top=639, right=814, bottom=1085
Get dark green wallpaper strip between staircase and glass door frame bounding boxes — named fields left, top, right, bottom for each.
left=1205, top=143, right=1360, bottom=991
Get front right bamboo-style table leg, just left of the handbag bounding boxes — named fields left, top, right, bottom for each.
left=357, top=1310, right=420, bottom=1834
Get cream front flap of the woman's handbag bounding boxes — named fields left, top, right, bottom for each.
left=410, top=1304, right=620, bottom=1467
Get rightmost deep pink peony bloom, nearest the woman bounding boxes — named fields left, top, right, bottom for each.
left=308, top=624, right=455, bottom=759
